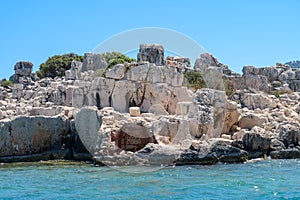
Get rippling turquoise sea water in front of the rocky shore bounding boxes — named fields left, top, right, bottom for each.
left=0, top=160, right=300, bottom=199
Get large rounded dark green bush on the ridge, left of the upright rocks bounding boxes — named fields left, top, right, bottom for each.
left=37, top=53, right=83, bottom=78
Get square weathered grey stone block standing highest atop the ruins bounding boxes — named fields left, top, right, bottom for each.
left=137, top=44, right=164, bottom=66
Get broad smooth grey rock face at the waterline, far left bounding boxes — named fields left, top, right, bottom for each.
left=0, top=116, right=71, bottom=158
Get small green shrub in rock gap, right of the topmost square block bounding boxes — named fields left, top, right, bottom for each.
left=184, top=70, right=206, bottom=90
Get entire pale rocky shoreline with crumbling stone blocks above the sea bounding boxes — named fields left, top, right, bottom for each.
left=0, top=45, right=300, bottom=166
